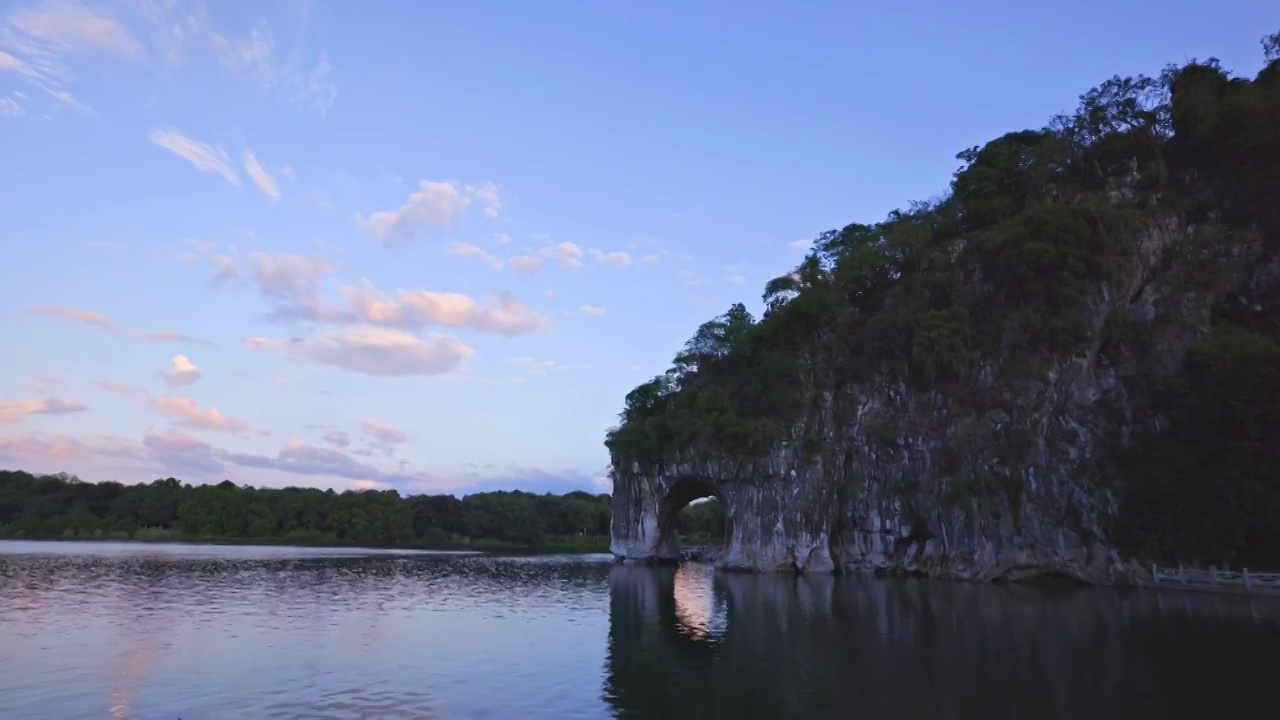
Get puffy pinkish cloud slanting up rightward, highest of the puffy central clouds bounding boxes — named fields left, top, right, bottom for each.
left=356, top=179, right=502, bottom=246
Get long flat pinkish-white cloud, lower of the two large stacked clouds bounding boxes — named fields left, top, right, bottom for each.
left=246, top=325, right=475, bottom=377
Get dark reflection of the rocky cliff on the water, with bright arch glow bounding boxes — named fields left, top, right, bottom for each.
left=604, top=565, right=1280, bottom=719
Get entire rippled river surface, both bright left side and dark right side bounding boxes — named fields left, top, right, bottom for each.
left=0, top=542, right=1280, bottom=720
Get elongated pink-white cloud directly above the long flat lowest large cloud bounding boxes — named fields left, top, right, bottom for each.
left=342, top=281, right=550, bottom=336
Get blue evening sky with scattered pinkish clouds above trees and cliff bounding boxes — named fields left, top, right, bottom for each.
left=0, top=0, right=1280, bottom=495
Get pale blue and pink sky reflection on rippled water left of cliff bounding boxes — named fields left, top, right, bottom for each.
left=0, top=542, right=612, bottom=720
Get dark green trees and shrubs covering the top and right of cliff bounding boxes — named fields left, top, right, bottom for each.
left=605, top=33, right=1280, bottom=568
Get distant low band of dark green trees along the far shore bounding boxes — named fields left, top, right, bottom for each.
left=0, top=470, right=611, bottom=548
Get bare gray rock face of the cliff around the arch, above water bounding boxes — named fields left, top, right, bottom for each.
left=611, top=208, right=1269, bottom=584
